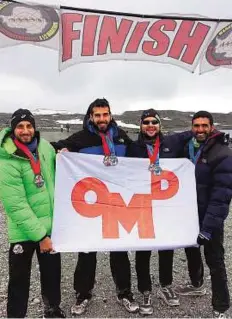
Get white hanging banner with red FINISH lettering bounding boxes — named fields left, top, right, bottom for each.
left=60, top=10, right=216, bottom=72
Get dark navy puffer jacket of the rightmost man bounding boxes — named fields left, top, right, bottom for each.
left=184, top=131, right=232, bottom=234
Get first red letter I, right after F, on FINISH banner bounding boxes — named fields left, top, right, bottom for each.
left=81, top=15, right=100, bottom=56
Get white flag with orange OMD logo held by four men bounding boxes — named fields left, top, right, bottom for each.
left=52, top=152, right=199, bottom=252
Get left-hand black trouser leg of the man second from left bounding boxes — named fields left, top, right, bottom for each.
left=74, top=252, right=97, bottom=298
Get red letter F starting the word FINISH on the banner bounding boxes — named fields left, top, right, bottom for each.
left=61, top=13, right=83, bottom=62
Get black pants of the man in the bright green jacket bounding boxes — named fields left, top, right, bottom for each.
left=7, top=242, right=61, bottom=318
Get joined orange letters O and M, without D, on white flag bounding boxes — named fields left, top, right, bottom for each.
left=71, top=178, right=155, bottom=238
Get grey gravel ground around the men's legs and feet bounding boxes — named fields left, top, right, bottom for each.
left=0, top=204, right=232, bottom=318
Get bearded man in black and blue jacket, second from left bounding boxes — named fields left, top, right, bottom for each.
left=51, top=99, right=139, bottom=316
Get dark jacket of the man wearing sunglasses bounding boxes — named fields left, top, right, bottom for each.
left=126, top=131, right=192, bottom=158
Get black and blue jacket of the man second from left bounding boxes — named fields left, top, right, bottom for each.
left=51, top=118, right=131, bottom=156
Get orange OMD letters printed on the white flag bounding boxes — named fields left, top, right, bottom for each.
left=71, top=171, right=179, bottom=238
